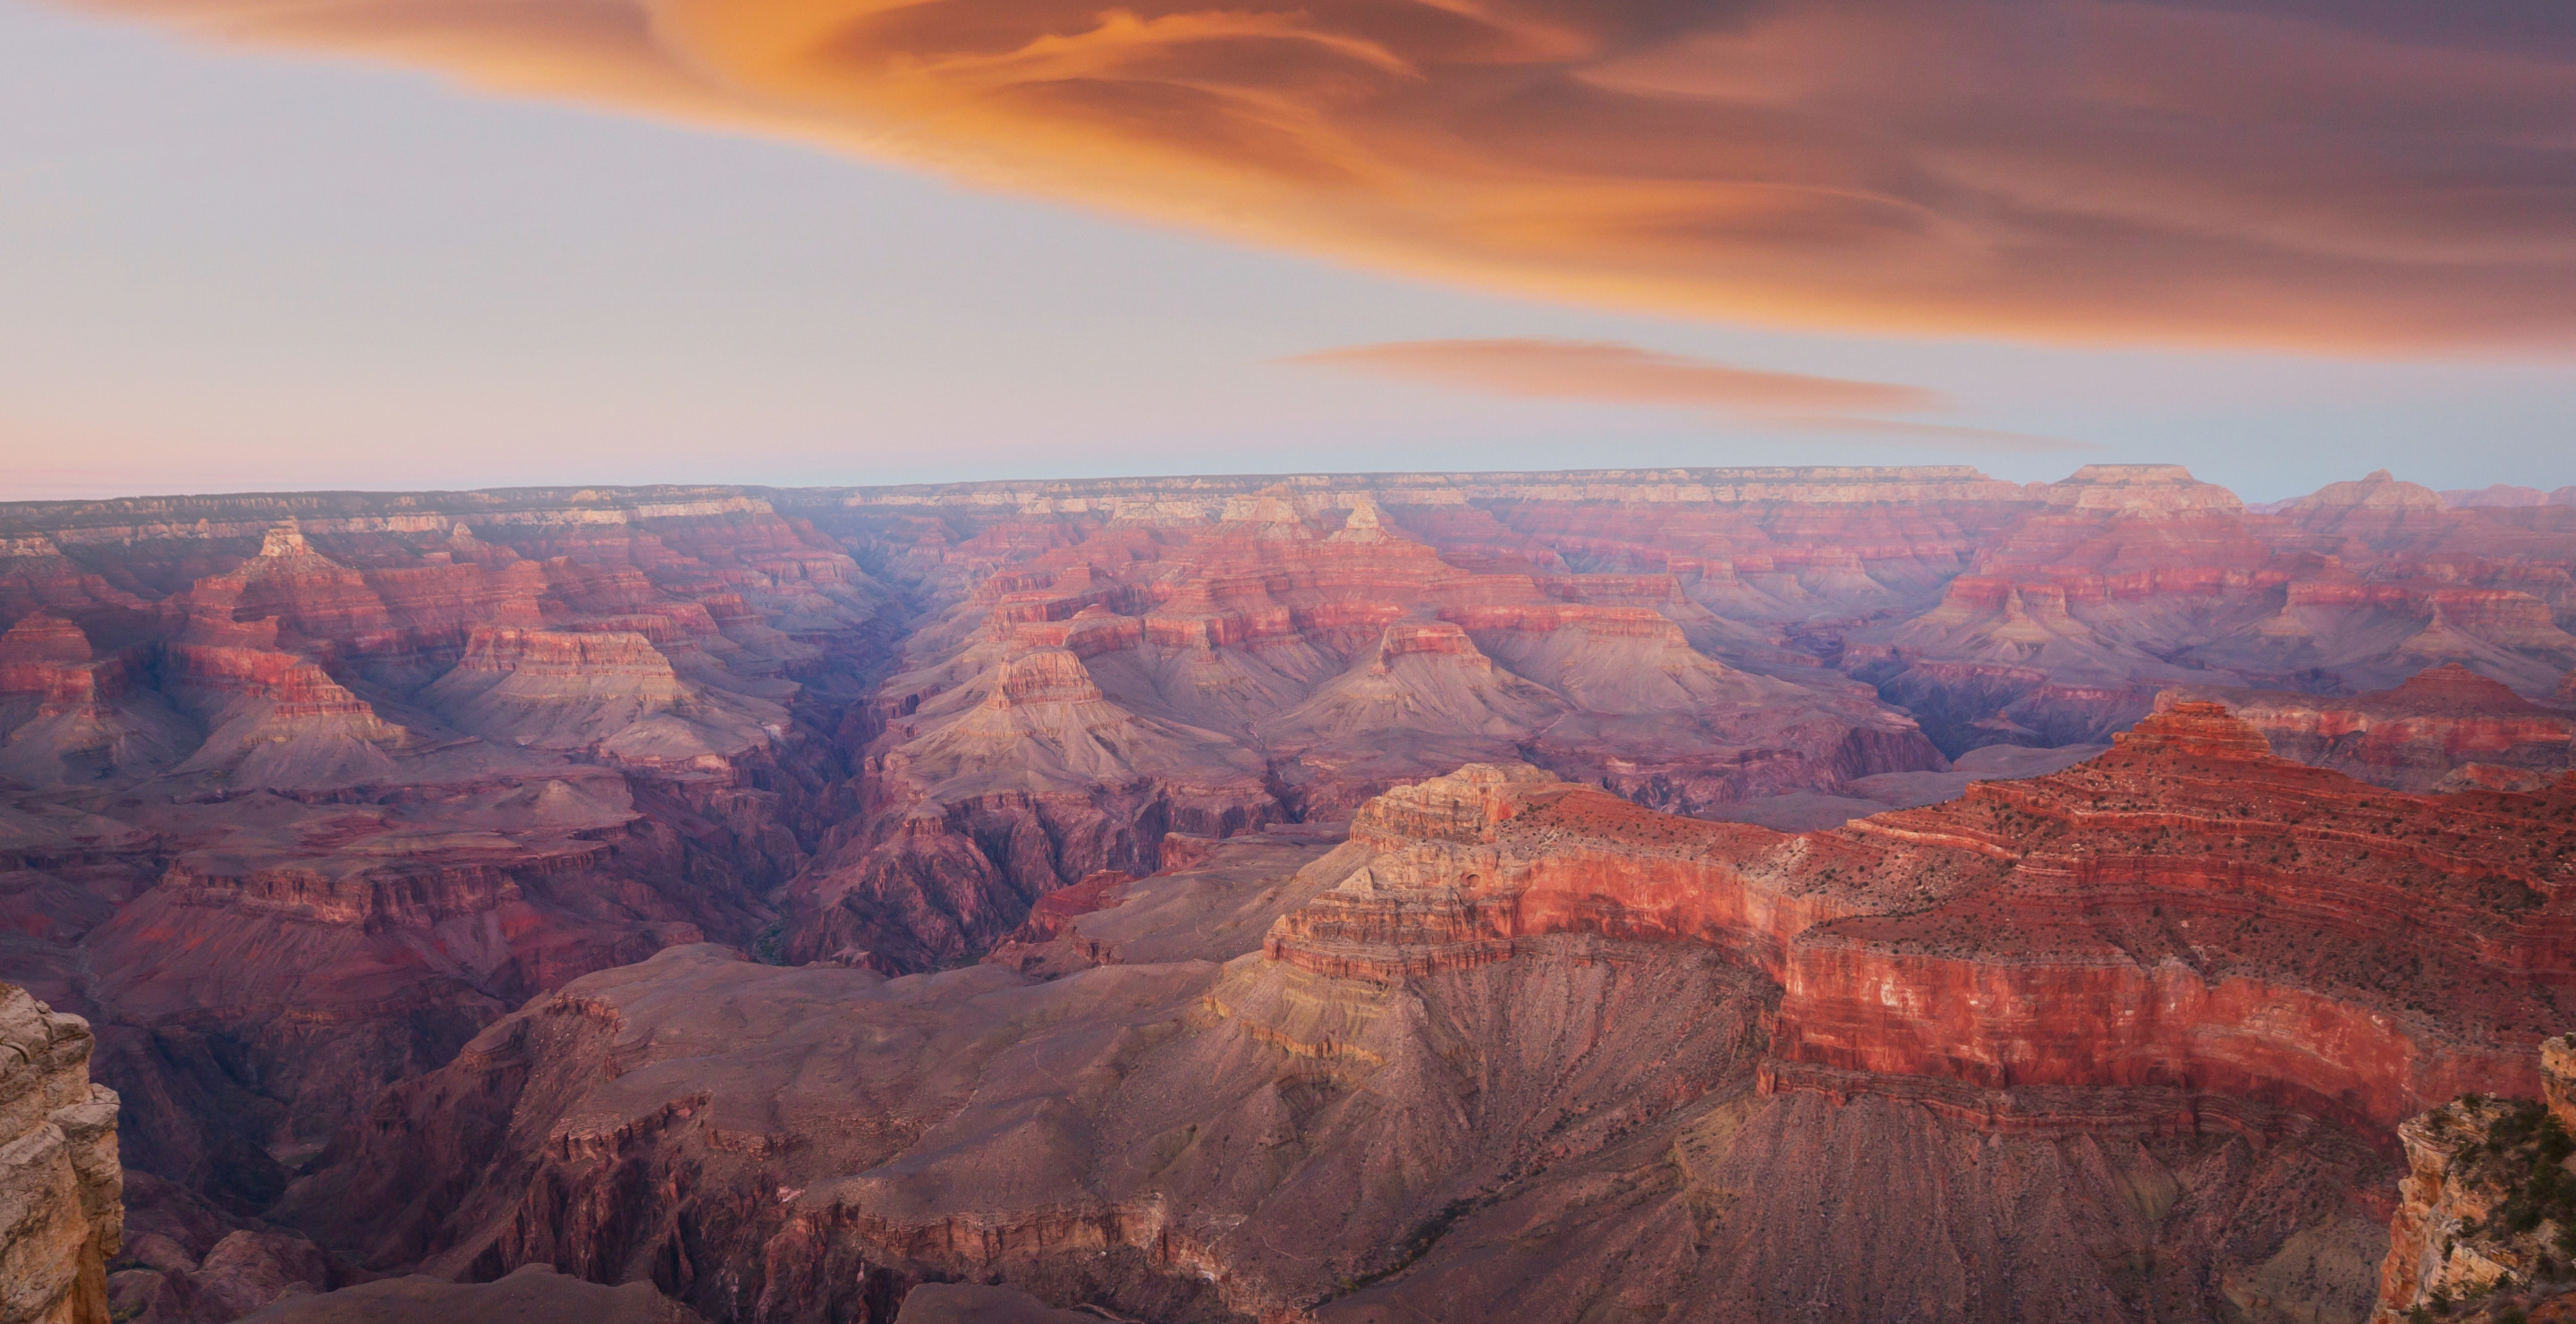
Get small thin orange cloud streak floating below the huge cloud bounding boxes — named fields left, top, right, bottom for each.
left=1280, top=337, right=2099, bottom=454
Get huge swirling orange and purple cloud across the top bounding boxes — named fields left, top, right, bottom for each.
left=70, top=0, right=2576, bottom=351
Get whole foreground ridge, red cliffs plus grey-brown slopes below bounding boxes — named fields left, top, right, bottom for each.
left=261, top=721, right=2568, bottom=1321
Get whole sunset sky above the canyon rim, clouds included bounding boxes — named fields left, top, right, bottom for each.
left=0, top=0, right=2576, bottom=500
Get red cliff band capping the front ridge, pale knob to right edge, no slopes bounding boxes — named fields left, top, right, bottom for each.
left=1265, top=703, right=2576, bottom=1125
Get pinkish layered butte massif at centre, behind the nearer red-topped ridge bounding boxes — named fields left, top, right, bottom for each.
left=788, top=487, right=1943, bottom=972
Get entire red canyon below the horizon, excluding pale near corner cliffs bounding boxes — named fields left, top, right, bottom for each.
left=0, top=466, right=2576, bottom=1324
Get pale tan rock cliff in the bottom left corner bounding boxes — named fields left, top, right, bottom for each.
left=0, top=984, right=123, bottom=1324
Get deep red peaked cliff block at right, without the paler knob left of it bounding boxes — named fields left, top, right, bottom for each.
left=1772, top=703, right=2576, bottom=1128
